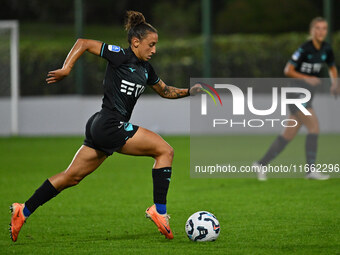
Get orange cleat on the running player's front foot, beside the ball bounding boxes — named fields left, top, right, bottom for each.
left=145, top=205, right=174, bottom=239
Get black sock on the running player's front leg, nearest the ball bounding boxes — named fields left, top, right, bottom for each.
left=152, top=167, right=171, bottom=204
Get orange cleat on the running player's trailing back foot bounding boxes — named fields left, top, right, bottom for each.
left=9, top=203, right=26, bottom=242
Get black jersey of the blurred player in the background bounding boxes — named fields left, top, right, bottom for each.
left=289, top=40, right=335, bottom=77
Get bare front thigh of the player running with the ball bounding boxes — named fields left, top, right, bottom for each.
left=118, top=127, right=173, bottom=157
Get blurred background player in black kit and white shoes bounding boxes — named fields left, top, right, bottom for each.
left=254, top=17, right=339, bottom=180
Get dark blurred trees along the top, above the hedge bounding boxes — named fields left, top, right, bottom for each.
left=0, top=0, right=340, bottom=35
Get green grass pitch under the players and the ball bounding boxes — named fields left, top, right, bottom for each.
left=0, top=135, right=340, bottom=254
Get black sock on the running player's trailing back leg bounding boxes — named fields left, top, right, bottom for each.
left=25, top=179, right=59, bottom=214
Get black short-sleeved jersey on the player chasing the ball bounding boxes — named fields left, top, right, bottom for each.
left=100, top=43, right=159, bottom=121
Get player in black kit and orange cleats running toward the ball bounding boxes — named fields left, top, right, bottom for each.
left=10, top=11, right=199, bottom=242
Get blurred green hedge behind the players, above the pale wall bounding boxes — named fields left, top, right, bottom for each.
left=20, top=32, right=340, bottom=96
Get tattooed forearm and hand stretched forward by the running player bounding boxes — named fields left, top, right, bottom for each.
left=152, top=79, right=201, bottom=99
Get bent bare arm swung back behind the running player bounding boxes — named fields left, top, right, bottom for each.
left=46, top=39, right=103, bottom=84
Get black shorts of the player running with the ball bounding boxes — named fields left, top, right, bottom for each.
left=84, top=109, right=138, bottom=156
